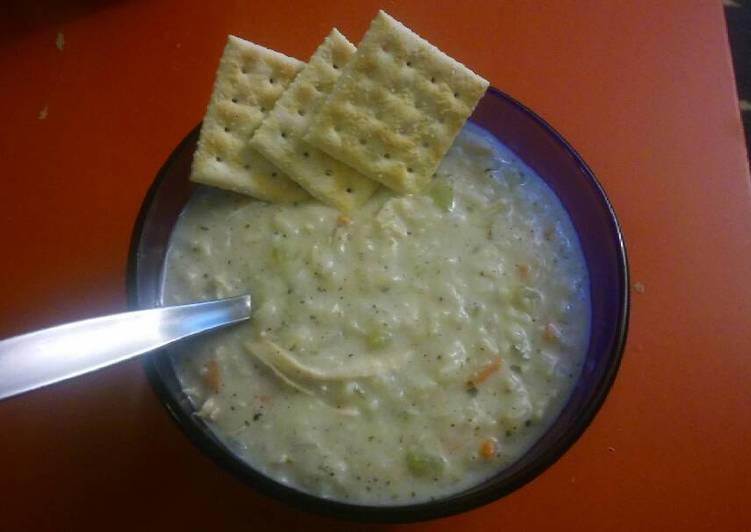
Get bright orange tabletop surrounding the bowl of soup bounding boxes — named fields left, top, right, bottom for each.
left=0, top=0, right=751, bottom=531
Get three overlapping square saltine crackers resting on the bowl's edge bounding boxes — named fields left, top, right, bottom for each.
left=191, top=11, right=488, bottom=211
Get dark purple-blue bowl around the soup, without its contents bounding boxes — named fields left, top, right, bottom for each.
left=127, top=88, right=629, bottom=522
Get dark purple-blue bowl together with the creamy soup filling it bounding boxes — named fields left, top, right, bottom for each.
left=128, top=88, right=628, bottom=522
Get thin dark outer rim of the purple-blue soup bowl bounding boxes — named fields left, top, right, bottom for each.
left=126, top=86, right=631, bottom=523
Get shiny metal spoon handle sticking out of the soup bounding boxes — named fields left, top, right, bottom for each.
left=0, top=295, right=251, bottom=399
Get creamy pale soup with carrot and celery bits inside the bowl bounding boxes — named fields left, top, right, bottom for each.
left=164, top=125, right=590, bottom=505
